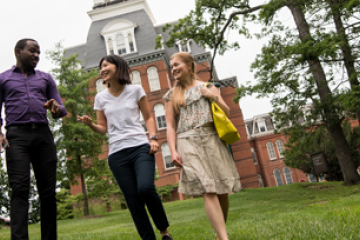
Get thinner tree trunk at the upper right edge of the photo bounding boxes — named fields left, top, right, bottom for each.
left=328, top=0, right=360, bottom=125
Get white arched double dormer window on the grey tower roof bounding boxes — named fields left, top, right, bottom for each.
left=100, top=19, right=137, bottom=55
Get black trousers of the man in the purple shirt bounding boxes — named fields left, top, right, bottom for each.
left=6, top=124, right=57, bottom=240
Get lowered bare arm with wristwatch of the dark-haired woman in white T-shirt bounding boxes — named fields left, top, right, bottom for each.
left=139, top=96, right=160, bottom=154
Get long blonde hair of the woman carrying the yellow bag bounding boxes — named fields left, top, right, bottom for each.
left=170, top=52, right=195, bottom=116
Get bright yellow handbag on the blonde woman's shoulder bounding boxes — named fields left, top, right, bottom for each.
left=205, top=82, right=240, bottom=145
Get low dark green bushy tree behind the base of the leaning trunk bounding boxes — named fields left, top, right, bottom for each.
left=282, top=121, right=360, bottom=181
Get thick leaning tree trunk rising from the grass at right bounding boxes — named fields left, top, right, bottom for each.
left=287, top=0, right=360, bottom=186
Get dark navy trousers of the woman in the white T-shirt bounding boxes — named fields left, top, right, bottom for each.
left=108, top=144, right=169, bottom=240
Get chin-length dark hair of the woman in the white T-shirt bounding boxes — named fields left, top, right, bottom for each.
left=99, top=55, right=131, bottom=85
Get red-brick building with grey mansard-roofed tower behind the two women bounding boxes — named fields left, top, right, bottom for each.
left=66, top=0, right=314, bottom=200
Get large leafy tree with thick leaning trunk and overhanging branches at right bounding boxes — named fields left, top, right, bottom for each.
left=156, top=0, right=360, bottom=185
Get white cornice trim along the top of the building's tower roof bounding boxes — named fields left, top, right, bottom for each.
left=87, top=0, right=156, bottom=25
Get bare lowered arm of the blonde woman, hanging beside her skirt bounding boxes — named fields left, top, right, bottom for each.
left=165, top=101, right=182, bottom=167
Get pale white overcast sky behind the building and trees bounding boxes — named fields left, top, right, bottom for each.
left=0, top=0, right=272, bottom=119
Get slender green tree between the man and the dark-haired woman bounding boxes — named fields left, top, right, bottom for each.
left=47, top=43, right=106, bottom=216
